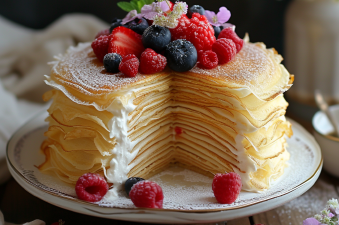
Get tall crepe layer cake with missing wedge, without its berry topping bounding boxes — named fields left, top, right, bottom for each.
left=39, top=43, right=293, bottom=191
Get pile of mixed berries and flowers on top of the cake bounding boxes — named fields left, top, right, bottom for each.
left=92, top=0, right=244, bottom=77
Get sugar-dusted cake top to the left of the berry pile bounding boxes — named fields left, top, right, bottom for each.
left=52, top=43, right=149, bottom=94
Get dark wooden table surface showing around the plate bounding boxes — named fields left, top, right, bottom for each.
left=0, top=110, right=339, bottom=225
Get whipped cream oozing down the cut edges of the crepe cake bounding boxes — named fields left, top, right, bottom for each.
left=45, top=71, right=285, bottom=197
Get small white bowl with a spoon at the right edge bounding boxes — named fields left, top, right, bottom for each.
left=312, top=105, right=339, bottom=177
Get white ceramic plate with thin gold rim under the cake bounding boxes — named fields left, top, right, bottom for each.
left=7, top=112, right=322, bottom=224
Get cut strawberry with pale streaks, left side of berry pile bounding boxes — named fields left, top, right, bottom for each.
left=108, top=27, right=145, bottom=58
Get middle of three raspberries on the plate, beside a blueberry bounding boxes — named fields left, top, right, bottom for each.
left=129, top=180, right=164, bottom=208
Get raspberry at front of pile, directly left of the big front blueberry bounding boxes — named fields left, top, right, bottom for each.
left=140, top=48, right=167, bottom=74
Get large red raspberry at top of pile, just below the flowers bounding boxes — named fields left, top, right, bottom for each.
left=187, top=13, right=215, bottom=51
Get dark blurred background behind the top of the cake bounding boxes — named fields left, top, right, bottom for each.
left=0, top=0, right=291, bottom=55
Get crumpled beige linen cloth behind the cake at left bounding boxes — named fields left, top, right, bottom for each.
left=0, top=14, right=108, bottom=225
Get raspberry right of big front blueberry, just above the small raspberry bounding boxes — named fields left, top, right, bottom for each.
left=212, top=38, right=237, bottom=64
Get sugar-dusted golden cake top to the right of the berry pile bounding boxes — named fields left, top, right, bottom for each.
left=189, top=43, right=289, bottom=96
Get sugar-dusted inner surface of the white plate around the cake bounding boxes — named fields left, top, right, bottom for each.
left=10, top=119, right=319, bottom=210
